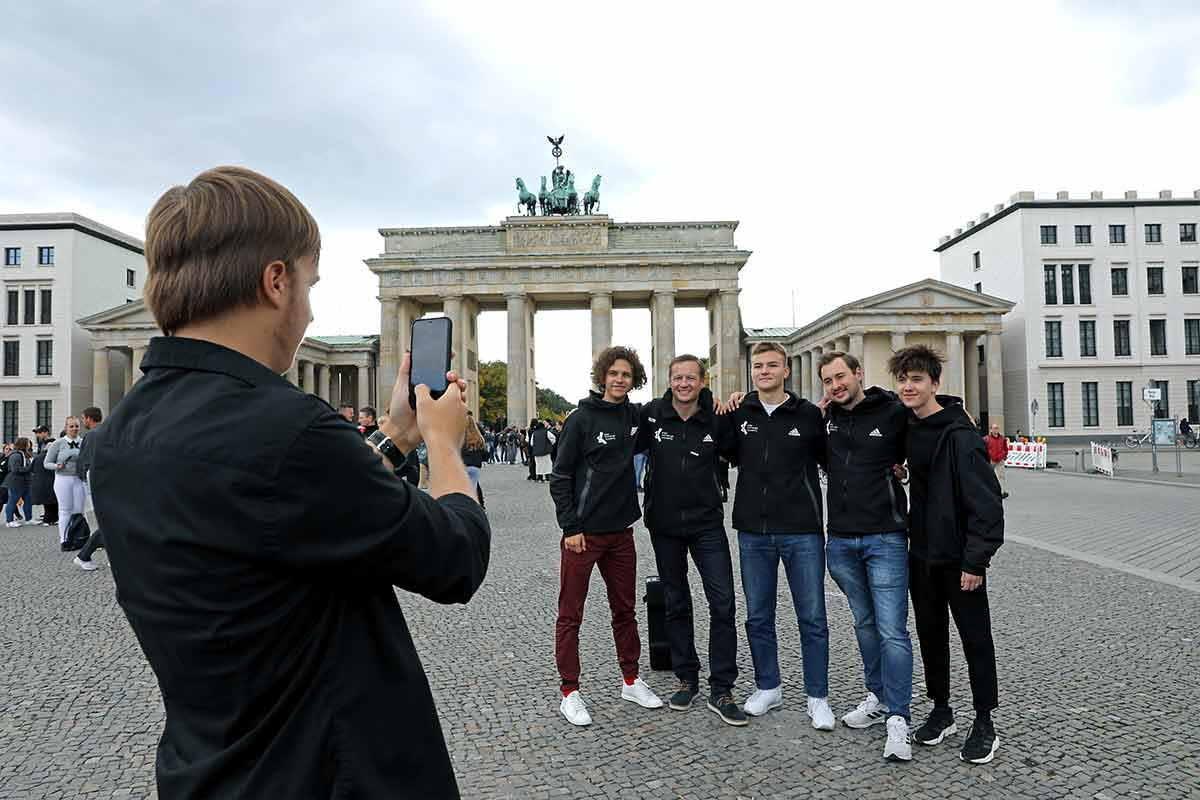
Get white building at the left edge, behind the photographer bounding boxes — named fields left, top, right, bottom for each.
left=0, top=213, right=146, bottom=441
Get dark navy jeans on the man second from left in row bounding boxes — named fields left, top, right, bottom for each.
left=650, top=528, right=738, bottom=697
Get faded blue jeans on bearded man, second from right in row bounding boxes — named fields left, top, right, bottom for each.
left=826, top=533, right=912, bottom=720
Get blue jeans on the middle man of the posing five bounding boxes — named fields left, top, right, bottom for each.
left=738, top=531, right=829, bottom=697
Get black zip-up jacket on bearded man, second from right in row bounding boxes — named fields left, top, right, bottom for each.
left=826, top=386, right=912, bottom=536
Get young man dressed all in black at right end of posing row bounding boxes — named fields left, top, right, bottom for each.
left=888, top=344, right=1004, bottom=764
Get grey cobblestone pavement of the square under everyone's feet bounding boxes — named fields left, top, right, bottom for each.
left=0, top=465, right=1200, bottom=800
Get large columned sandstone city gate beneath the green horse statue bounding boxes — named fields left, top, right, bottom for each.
left=366, top=215, right=750, bottom=421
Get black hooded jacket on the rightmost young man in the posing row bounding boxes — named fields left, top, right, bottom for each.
left=907, top=396, right=1004, bottom=575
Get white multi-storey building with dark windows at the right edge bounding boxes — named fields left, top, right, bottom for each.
left=935, top=191, right=1200, bottom=438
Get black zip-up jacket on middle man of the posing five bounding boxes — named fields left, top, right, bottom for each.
left=721, top=391, right=826, bottom=534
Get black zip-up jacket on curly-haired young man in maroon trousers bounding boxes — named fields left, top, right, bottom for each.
left=550, top=392, right=642, bottom=536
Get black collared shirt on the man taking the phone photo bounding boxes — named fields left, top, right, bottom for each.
left=85, top=337, right=490, bottom=800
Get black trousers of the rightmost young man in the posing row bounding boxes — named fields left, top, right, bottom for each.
left=908, top=555, right=1000, bottom=712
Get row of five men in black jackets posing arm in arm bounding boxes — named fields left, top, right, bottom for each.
left=551, top=343, right=1003, bottom=763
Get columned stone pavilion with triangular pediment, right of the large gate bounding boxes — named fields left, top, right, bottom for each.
left=745, top=278, right=1013, bottom=429
